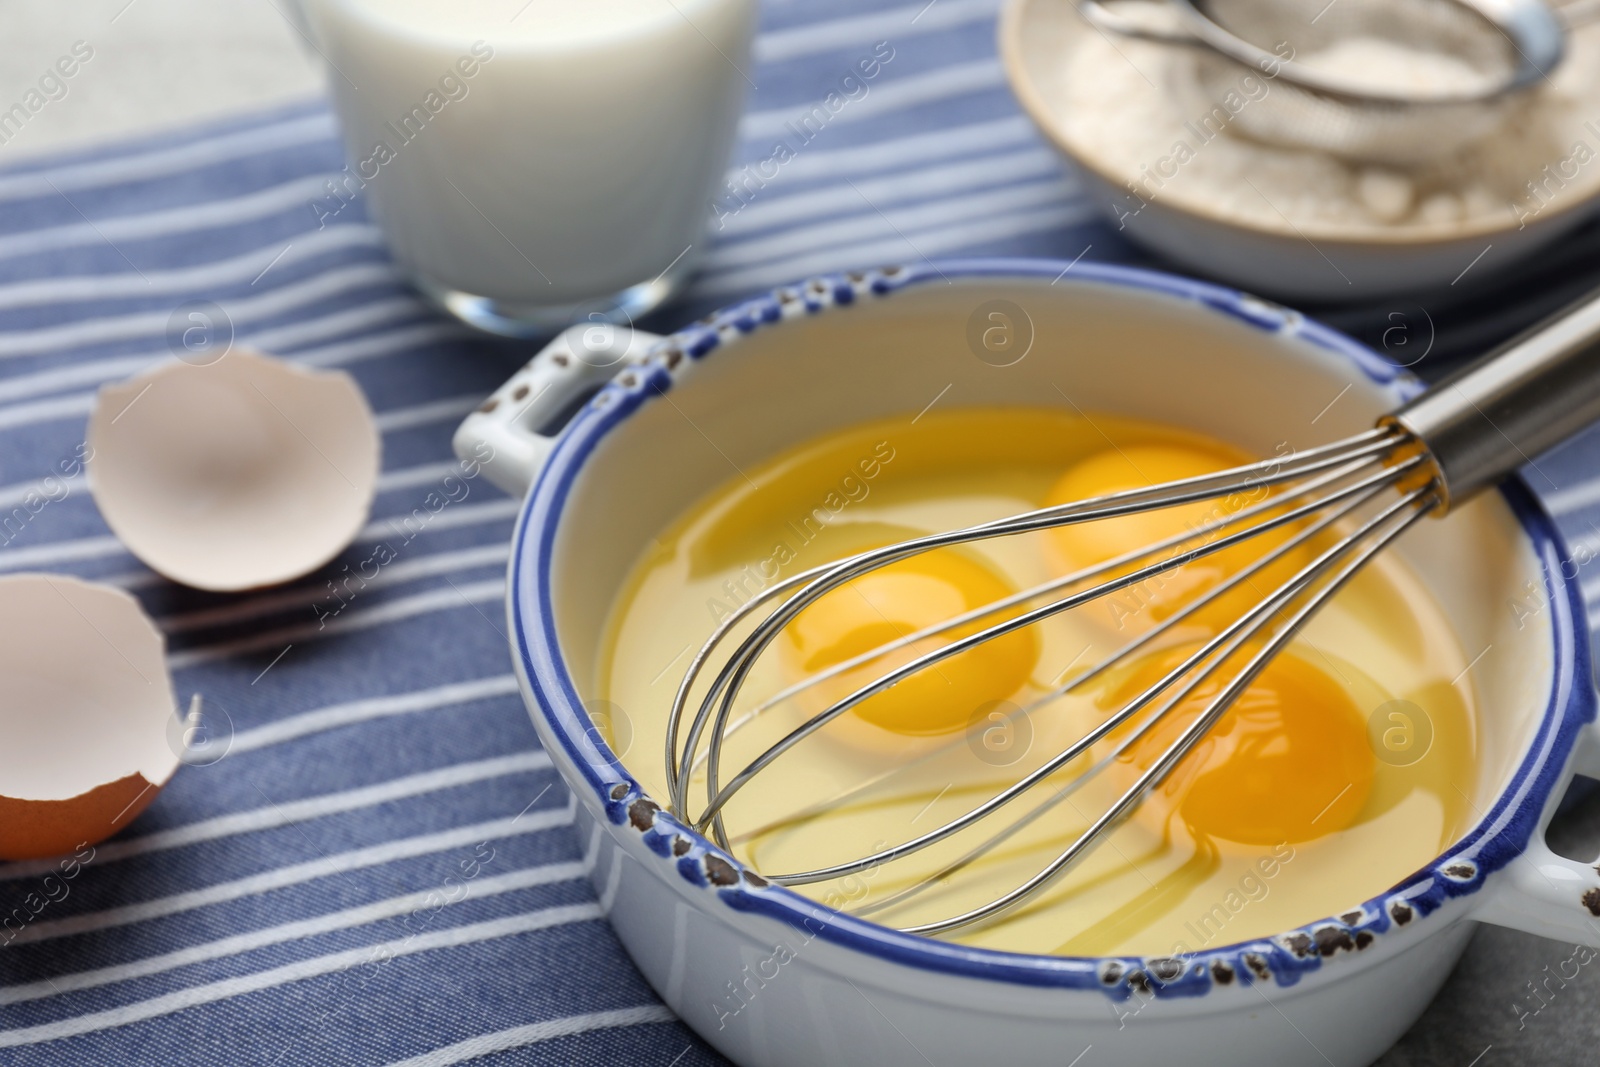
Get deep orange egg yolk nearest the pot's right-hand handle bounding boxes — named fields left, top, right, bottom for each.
left=1099, top=645, right=1376, bottom=845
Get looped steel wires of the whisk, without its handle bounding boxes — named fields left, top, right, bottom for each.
left=666, top=415, right=1459, bottom=934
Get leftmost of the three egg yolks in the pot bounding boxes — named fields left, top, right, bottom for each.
left=779, top=549, right=1038, bottom=734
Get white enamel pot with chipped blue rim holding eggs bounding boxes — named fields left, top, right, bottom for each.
left=456, top=259, right=1600, bottom=1067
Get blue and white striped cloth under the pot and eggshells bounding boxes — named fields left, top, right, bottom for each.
left=0, top=0, right=1600, bottom=1067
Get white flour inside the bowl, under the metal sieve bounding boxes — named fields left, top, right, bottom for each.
left=1053, top=32, right=1600, bottom=235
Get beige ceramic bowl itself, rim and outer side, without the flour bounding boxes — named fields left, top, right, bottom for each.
left=1000, top=0, right=1600, bottom=301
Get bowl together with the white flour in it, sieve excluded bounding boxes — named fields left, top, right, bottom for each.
left=1000, top=0, right=1600, bottom=301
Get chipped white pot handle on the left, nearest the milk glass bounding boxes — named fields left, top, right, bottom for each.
left=451, top=323, right=661, bottom=496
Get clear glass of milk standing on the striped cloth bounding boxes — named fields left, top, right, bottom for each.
left=301, top=0, right=755, bottom=336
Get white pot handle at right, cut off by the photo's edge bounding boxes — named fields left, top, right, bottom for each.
left=1474, top=723, right=1600, bottom=947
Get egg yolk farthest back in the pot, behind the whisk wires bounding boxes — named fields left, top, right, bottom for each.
left=1045, top=445, right=1310, bottom=630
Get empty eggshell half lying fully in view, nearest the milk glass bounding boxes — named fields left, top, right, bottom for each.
left=86, top=349, right=379, bottom=592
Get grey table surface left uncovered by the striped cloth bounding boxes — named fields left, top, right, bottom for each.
left=0, top=0, right=1600, bottom=1067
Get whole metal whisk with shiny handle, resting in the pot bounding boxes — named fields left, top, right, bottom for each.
left=666, top=289, right=1600, bottom=934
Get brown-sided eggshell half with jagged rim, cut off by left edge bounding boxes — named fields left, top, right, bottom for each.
left=0, top=574, right=179, bottom=859
